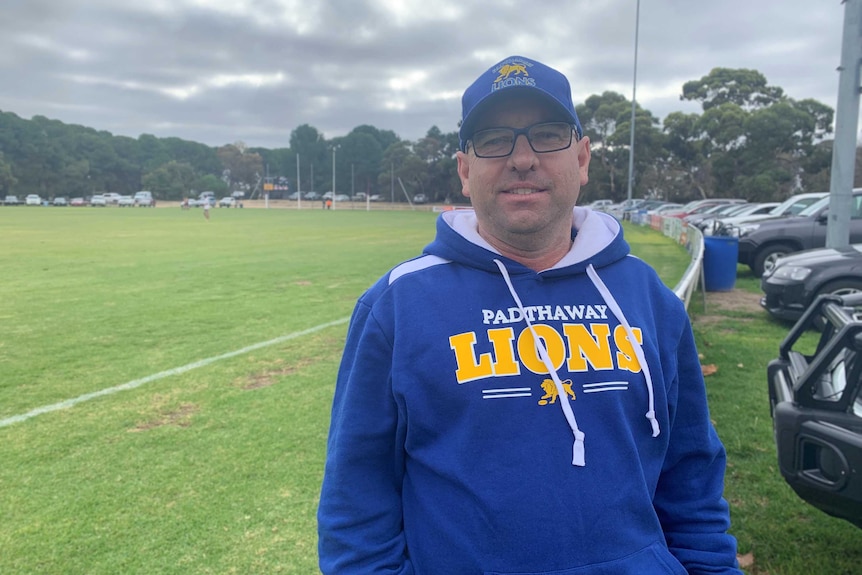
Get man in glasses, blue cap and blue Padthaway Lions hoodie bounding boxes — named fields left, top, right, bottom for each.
left=318, top=56, right=740, bottom=575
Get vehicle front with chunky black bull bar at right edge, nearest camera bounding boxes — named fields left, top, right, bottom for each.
left=766, top=294, right=862, bottom=528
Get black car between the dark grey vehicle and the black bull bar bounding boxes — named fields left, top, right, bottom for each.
left=760, top=244, right=862, bottom=321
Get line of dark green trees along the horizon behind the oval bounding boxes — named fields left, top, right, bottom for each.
left=0, top=68, right=862, bottom=203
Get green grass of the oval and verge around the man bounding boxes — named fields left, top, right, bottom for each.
left=0, top=207, right=862, bottom=575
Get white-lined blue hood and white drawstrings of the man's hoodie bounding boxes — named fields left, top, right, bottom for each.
left=425, top=207, right=660, bottom=467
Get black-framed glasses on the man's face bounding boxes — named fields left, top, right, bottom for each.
left=470, top=122, right=575, bottom=158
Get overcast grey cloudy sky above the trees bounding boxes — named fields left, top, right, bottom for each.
left=0, top=0, right=844, bottom=148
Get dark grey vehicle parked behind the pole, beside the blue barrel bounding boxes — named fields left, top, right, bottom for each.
left=738, top=188, right=862, bottom=276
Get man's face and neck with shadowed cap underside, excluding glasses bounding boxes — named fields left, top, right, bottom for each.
left=458, top=94, right=590, bottom=249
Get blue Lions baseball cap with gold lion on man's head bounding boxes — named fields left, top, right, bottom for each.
left=458, top=56, right=584, bottom=152
